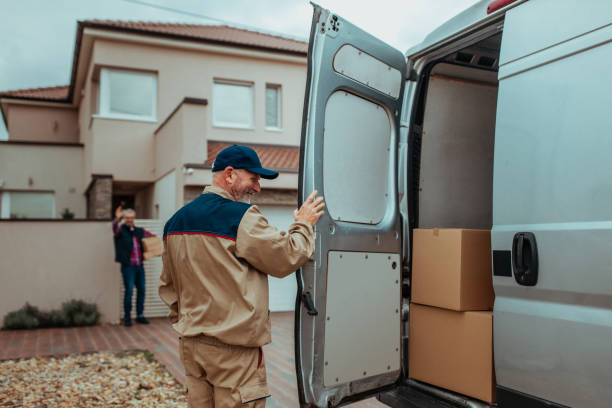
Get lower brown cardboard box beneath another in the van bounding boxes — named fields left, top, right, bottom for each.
left=408, top=304, right=495, bottom=402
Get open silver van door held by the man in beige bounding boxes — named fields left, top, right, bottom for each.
left=295, top=5, right=406, bottom=407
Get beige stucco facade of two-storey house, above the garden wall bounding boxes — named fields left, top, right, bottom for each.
left=0, top=22, right=306, bottom=218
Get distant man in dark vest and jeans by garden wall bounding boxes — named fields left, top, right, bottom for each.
left=113, top=206, right=155, bottom=327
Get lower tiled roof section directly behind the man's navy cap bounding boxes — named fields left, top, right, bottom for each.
left=201, top=142, right=300, bottom=173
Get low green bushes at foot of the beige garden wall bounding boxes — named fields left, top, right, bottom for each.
left=3, top=300, right=100, bottom=330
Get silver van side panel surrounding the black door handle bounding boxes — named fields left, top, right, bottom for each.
left=491, top=26, right=612, bottom=407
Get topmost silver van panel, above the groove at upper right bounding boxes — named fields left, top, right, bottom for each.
left=499, top=0, right=612, bottom=66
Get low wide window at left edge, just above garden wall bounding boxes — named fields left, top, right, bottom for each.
left=0, top=191, right=55, bottom=218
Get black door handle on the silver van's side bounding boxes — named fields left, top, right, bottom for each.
left=512, top=232, right=539, bottom=286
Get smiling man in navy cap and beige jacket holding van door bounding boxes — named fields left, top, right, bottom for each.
left=159, top=145, right=325, bottom=408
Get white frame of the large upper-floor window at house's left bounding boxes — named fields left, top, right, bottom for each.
left=93, top=67, right=159, bottom=122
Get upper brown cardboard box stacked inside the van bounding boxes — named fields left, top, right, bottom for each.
left=411, top=228, right=495, bottom=311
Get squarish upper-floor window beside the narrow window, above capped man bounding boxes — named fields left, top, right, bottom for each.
left=213, top=81, right=253, bottom=129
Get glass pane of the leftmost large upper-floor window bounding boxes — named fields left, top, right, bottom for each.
left=108, top=71, right=156, bottom=117
